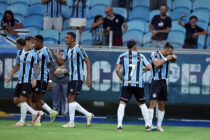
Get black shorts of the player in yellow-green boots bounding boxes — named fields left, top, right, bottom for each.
left=32, top=80, right=47, bottom=94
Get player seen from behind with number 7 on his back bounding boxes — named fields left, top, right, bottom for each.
left=116, top=40, right=151, bottom=131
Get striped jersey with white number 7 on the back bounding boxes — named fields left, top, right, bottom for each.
left=117, top=51, right=149, bottom=88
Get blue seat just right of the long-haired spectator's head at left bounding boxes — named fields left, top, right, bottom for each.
left=22, top=15, right=43, bottom=30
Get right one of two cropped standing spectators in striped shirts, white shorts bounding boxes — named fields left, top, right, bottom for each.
left=70, top=0, right=86, bottom=35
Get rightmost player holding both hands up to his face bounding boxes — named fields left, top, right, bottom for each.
left=148, top=43, right=177, bottom=132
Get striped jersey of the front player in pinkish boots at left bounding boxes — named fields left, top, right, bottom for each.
left=16, top=49, right=38, bottom=84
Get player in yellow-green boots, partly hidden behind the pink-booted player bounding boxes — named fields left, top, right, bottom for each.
left=32, top=35, right=58, bottom=126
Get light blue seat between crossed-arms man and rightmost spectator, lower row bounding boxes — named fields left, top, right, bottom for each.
left=167, top=31, right=185, bottom=48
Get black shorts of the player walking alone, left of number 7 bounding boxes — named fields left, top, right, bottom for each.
left=67, top=80, right=83, bottom=95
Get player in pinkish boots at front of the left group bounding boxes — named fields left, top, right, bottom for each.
left=5, top=36, right=43, bottom=126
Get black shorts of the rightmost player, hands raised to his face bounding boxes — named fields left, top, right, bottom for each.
left=150, top=80, right=168, bottom=101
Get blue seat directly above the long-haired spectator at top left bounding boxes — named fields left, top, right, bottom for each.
left=7, top=3, right=28, bottom=17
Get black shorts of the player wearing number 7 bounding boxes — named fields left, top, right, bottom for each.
left=120, top=86, right=145, bottom=103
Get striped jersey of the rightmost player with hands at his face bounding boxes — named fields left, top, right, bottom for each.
left=149, top=51, right=169, bottom=83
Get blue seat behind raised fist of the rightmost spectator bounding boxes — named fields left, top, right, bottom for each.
left=170, top=8, right=191, bottom=23
